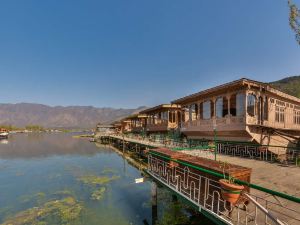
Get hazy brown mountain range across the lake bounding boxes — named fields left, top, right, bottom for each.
left=0, top=103, right=146, bottom=128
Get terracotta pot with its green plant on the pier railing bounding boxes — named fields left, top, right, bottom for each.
left=219, top=162, right=244, bottom=205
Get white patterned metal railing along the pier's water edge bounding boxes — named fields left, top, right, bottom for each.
left=148, top=154, right=300, bottom=225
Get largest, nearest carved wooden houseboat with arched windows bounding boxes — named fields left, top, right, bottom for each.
left=172, top=78, right=300, bottom=153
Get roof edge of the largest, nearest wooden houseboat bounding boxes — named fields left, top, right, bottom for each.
left=172, top=78, right=300, bottom=105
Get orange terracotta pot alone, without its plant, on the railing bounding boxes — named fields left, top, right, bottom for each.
left=219, top=179, right=245, bottom=205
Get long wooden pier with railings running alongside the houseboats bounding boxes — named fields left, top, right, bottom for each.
left=97, top=133, right=300, bottom=225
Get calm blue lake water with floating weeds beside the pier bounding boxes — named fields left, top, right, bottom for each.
left=0, top=134, right=212, bottom=225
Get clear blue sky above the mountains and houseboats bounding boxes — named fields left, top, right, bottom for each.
left=0, top=0, right=300, bottom=108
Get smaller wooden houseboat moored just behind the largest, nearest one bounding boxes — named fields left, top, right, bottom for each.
left=140, top=104, right=182, bottom=134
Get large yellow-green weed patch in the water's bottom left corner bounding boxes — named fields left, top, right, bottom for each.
left=3, top=197, right=82, bottom=225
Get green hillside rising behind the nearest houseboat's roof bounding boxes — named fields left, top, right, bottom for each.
left=270, top=76, right=300, bottom=98
